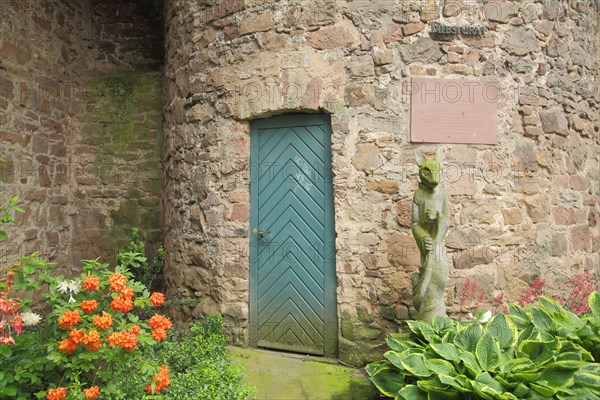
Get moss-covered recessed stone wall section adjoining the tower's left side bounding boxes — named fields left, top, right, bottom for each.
left=73, top=72, right=163, bottom=263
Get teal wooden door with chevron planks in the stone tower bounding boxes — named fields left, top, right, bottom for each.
left=250, top=114, right=337, bottom=357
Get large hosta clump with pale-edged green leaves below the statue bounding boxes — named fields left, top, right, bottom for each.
left=366, top=292, right=600, bottom=400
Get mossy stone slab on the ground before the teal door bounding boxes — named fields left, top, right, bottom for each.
left=229, top=347, right=380, bottom=400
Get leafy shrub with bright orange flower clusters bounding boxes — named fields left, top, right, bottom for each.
left=0, top=257, right=172, bottom=400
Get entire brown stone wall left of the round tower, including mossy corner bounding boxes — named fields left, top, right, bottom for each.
left=0, top=0, right=162, bottom=270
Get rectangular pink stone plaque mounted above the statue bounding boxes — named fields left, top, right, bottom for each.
left=404, top=78, right=498, bottom=144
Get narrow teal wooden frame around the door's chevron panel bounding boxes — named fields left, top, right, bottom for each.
left=248, top=114, right=339, bottom=357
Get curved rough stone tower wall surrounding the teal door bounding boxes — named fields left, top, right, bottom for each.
left=163, top=0, right=600, bottom=364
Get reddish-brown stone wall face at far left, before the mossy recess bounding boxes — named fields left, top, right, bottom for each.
left=0, top=1, right=92, bottom=265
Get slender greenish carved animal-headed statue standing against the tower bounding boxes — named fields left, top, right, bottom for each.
left=412, top=149, right=449, bottom=322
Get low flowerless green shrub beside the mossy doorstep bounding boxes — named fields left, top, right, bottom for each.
left=153, top=314, right=252, bottom=400
